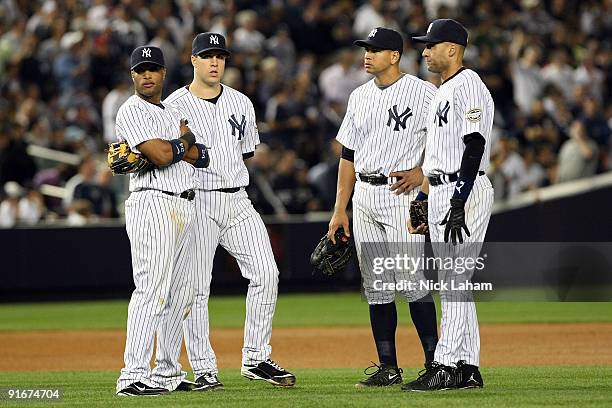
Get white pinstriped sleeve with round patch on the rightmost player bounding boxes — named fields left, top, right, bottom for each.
left=455, top=82, right=488, bottom=138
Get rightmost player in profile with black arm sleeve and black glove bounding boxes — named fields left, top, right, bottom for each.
left=402, top=19, right=494, bottom=391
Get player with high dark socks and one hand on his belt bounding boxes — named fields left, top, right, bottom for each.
left=328, top=27, right=438, bottom=387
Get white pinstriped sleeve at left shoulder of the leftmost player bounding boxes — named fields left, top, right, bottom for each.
left=115, top=105, right=160, bottom=152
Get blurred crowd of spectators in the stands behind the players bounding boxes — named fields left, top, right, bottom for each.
left=0, top=0, right=612, bottom=226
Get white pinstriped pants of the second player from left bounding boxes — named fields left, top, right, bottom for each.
left=184, top=189, right=279, bottom=378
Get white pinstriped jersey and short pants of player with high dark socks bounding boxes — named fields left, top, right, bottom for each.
left=337, top=74, right=436, bottom=304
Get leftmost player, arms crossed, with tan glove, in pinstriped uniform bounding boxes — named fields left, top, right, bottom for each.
left=116, top=46, right=198, bottom=396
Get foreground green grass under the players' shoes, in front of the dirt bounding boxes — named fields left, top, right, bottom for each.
left=0, top=367, right=612, bottom=408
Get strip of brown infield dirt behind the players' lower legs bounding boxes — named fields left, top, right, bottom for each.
left=0, top=323, right=612, bottom=371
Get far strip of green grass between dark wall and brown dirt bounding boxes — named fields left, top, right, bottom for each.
left=0, top=293, right=612, bottom=330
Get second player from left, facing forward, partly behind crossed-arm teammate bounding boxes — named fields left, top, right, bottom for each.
left=165, top=32, right=295, bottom=390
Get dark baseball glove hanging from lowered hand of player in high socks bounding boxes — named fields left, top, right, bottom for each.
left=310, top=228, right=353, bottom=276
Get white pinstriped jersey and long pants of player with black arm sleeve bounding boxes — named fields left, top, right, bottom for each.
left=423, top=69, right=494, bottom=366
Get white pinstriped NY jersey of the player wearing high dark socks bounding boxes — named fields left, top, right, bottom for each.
left=337, top=74, right=436, bottom=176
